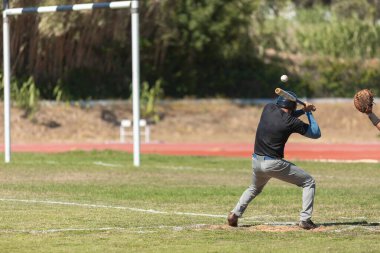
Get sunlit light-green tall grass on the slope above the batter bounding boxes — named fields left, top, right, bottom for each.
left=260, top=8, right=380, bottom=59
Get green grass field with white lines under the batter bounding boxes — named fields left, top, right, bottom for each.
left=0, top=151, right=380, bottom=252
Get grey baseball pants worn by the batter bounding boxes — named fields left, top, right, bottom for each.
left=232, top=156, right=315, bottom=221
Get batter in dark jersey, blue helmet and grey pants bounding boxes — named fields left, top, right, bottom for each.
left=227, top=91, right=321, bottom=229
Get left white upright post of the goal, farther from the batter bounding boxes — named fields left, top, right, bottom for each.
left=3, top=0, right=11, bottom=163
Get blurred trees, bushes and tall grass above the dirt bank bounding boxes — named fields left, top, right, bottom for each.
left=0, top=0, right=380, bottom=100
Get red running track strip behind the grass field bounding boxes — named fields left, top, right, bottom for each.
left=0, top=143, right=380, bottom=162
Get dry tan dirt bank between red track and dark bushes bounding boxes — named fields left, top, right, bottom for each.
left=0, top=99, right=380, bottom=144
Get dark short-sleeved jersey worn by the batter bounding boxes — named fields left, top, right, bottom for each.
left=255, top=103, right=309, bottom=158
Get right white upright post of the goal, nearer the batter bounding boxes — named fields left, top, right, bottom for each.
left=131, top=0, right=140, bottom=167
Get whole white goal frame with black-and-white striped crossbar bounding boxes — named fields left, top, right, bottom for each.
left=3, top=0, right=140, bottom=167
